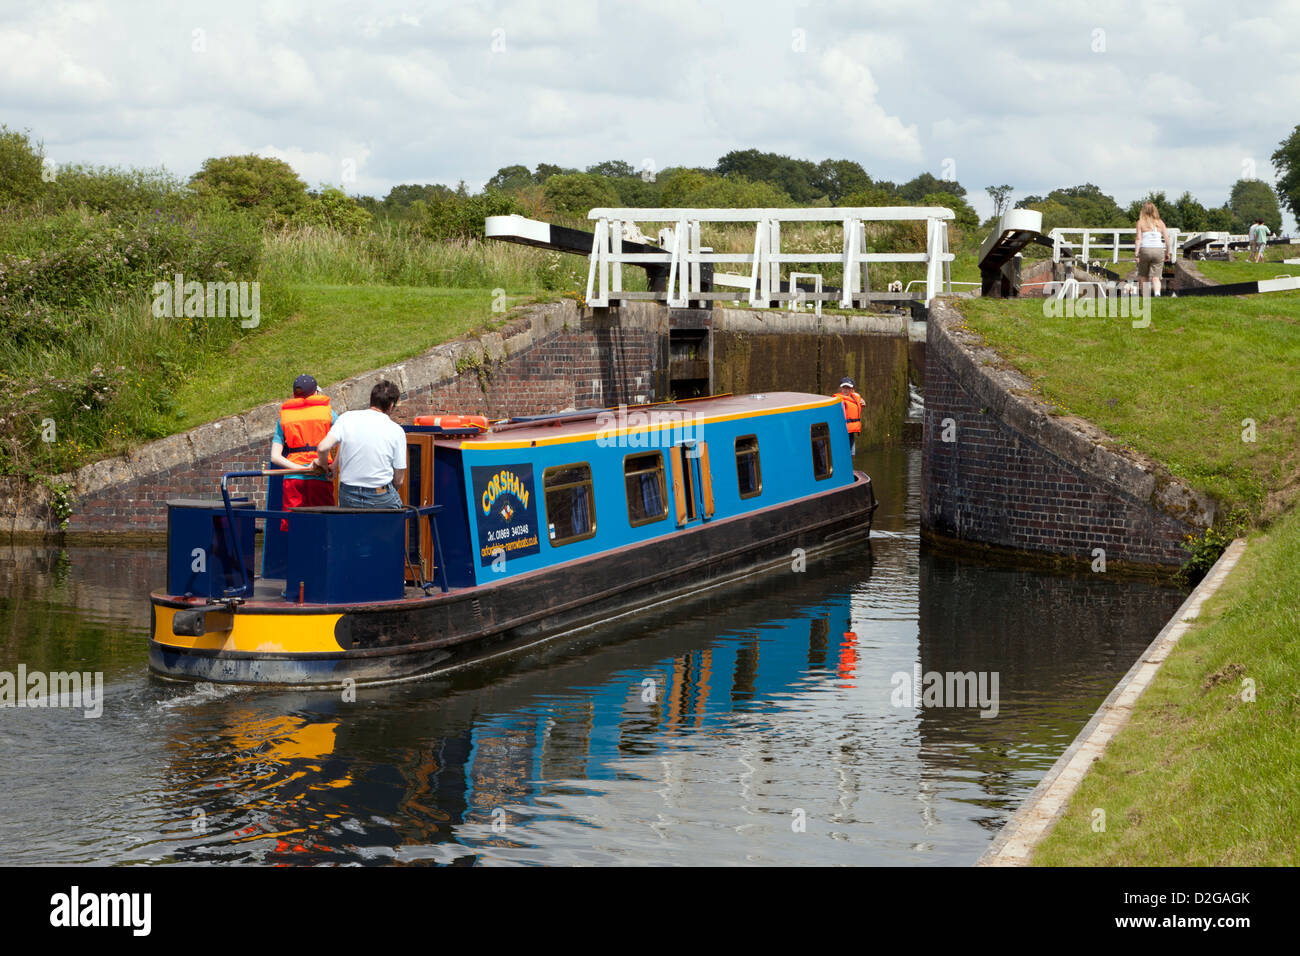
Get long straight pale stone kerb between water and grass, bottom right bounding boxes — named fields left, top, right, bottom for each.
left=975, top=538, right=1245, bottom=866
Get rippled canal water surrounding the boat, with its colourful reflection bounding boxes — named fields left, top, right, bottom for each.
left=0, top=447, right=1183, bottom=865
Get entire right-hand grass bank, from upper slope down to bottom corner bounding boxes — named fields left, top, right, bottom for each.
left=961, top=290, right=1300, bottom=866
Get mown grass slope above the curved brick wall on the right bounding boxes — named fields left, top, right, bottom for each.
left=959, top=293, right=1300, bottom=518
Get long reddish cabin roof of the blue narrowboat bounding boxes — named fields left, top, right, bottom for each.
left=421, top=392, right=840, bottom=449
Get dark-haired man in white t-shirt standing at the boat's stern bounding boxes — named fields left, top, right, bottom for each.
left=316, top=381, right=406, bottom=507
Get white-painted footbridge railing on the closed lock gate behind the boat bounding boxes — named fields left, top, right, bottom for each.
left=586, top=206, right=953, bottom=308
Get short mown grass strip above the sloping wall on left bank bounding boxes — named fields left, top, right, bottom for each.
left=174, top=285, right=525, bottom=432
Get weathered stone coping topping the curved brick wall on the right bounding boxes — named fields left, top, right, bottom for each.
left=926, top=299, right=1216, bottom=529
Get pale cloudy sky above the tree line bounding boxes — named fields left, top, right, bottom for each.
left=0, top=0, right=1300, bottom=225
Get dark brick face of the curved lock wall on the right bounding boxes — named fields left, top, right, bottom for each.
left=922, top=303, right=1201, bottom=566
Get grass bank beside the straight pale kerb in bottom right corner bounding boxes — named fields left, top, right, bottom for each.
left=1034, top=512, right=1300, bottom=866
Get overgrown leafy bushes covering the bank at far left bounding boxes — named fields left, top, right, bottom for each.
left=0, top=206, right=266, bottom=477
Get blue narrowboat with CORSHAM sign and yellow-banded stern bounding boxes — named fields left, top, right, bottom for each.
left=150, top=393, right=876, bottom=687
